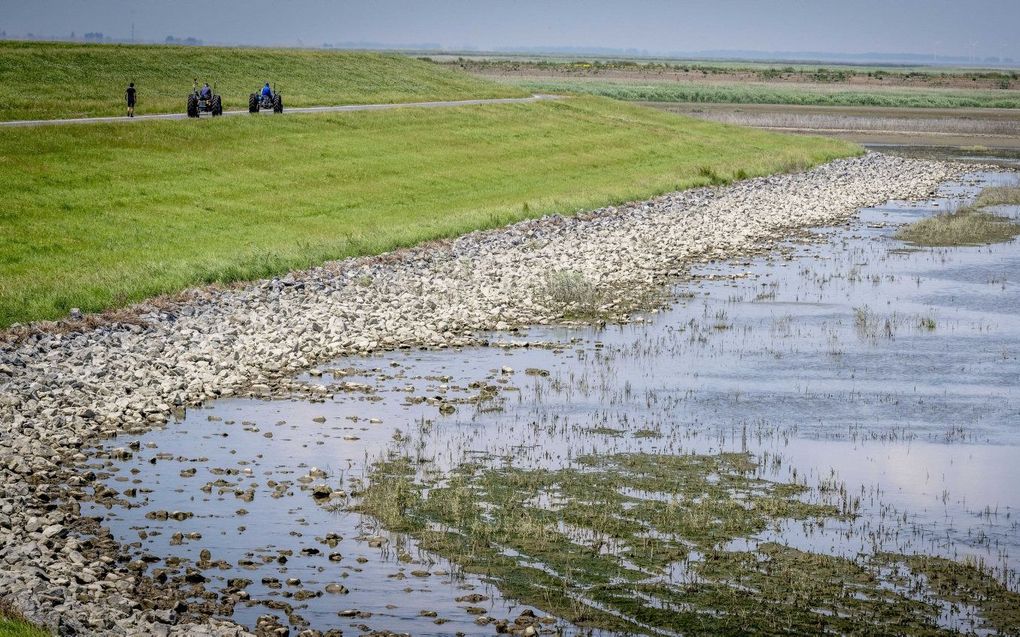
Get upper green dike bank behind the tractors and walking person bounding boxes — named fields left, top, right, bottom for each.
left=0, top=42, right=525, bottom=120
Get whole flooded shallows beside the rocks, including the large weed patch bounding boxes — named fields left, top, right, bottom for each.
left=83, top=168, right=1020, bottom=635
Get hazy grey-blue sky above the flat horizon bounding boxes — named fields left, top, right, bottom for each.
left=0, top=0, right=1020, bottom=58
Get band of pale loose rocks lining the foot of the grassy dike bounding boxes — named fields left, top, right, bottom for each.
left=0, top=154, right=987, bottom=635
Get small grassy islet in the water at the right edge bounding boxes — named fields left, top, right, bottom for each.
left=896, top=187, right=1020, bottom=248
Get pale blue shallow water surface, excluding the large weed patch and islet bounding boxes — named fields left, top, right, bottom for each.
left=83, top=166, right=1020, bottom=635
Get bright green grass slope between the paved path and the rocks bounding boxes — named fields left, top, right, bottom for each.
left=0, top=98, right=861, bottom=326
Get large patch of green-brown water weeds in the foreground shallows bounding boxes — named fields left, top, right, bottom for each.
left=357, top=453, right=1020, bottom=635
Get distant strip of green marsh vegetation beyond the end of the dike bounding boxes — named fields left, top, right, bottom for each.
left=510, top=77, right=1020, bottom=108
